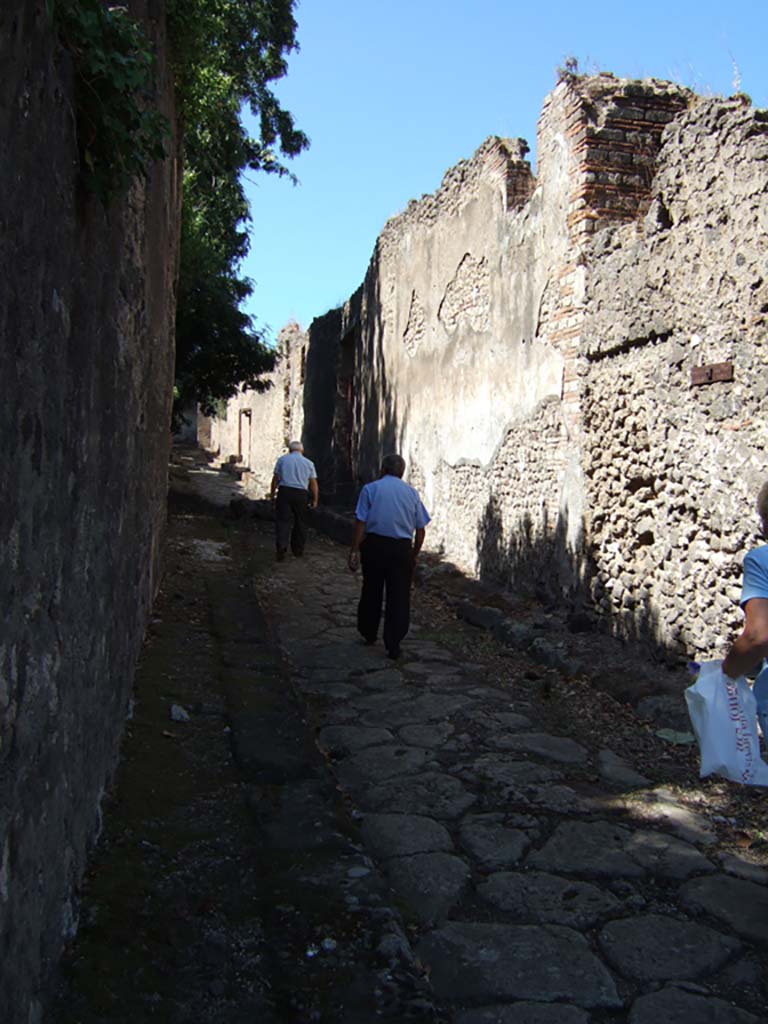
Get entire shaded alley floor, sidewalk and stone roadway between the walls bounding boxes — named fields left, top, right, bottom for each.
left=50, top=449, right=768, bottom=1024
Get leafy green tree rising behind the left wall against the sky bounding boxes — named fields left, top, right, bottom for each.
left=169, top=0, right=307, bottom=415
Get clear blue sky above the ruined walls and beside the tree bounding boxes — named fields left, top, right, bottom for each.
left=243, top=0, right=768, bottom=346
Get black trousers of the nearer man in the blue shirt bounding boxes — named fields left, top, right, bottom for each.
left=357, top=534, right=413, bottom=650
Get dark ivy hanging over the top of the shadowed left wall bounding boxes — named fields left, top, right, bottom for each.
left=46, top=0, right=169, bottom=204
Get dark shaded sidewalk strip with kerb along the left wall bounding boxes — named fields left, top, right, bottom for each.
left=52, top=461, right=437, bottom=1024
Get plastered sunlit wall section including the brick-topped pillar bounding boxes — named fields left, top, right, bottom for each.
left=350, top=76, right=688, bottom=594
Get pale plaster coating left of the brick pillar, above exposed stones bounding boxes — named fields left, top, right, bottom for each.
left=357, top=131, right=567, bottom=507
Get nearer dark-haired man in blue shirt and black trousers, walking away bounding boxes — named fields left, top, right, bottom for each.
left=349, top=455, right=430, bottom=658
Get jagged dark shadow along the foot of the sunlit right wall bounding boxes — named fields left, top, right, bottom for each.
left=477, top=495, right=685, bottom=665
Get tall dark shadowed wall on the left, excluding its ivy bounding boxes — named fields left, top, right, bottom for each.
left=0, top=0, right=179, bottom=1024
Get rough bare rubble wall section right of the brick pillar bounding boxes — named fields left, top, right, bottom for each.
left=584, top=99, right=768, bottom=655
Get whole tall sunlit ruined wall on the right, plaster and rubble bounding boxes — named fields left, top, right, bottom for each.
left=210, top=75, right=768, bottom=657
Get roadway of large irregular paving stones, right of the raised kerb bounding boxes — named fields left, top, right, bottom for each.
left=255, top=542, right=768, bottom=1024
